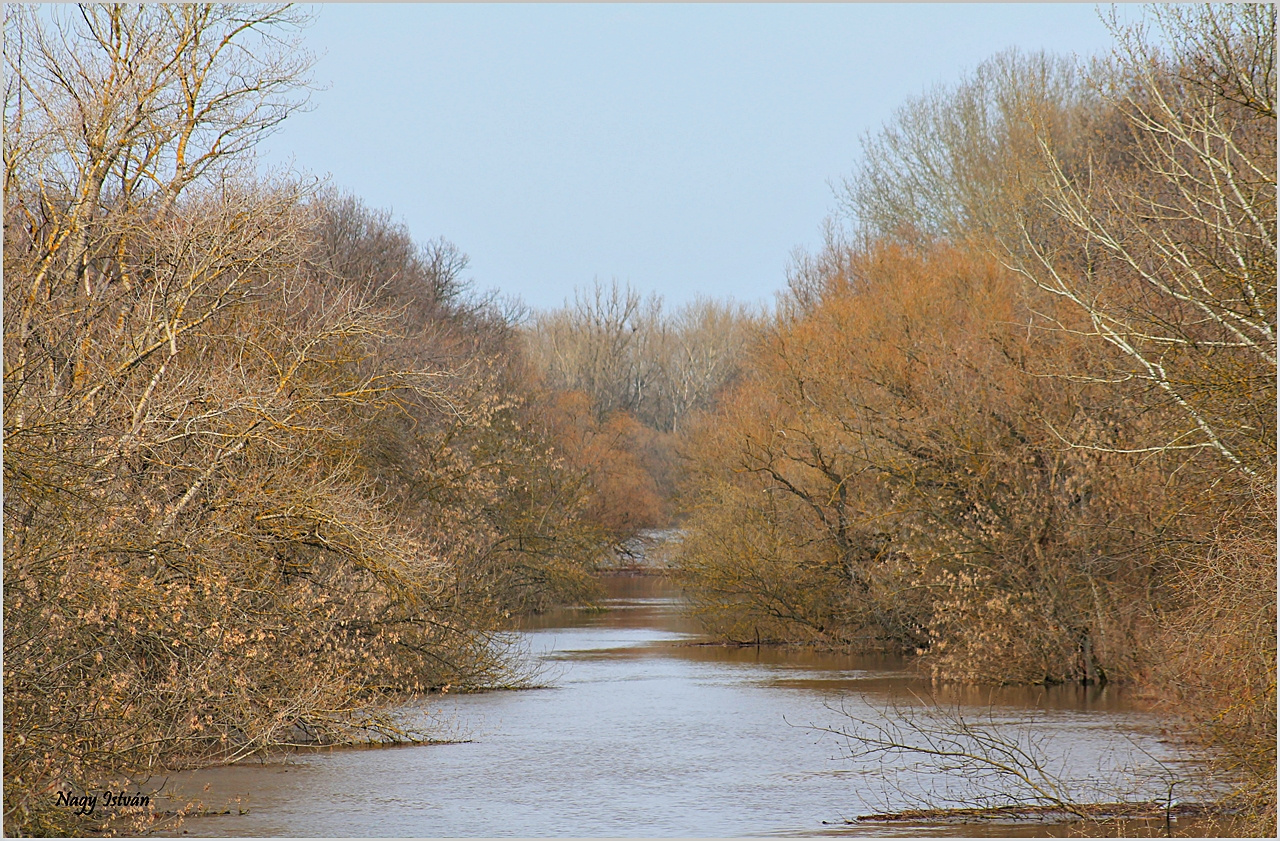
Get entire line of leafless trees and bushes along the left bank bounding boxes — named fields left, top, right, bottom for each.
left=4, top=5, right=611, bottom=835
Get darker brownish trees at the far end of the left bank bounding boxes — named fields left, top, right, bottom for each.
left=315, top=196, right=607, bottom=609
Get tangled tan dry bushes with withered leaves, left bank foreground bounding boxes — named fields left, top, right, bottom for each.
left=5, top=184, right=519, bottom=827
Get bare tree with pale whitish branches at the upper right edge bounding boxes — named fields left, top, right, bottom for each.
left=1007, top=4, right=1276, bottom=474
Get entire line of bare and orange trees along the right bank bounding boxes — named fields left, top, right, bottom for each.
left=677, top=4, right=1276, bottom=832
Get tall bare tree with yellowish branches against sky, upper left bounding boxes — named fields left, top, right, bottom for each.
left=4, top=5, right=307, bottom=450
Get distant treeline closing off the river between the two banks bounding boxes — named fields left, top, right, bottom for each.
left=524, top=282, right=758, bottom=535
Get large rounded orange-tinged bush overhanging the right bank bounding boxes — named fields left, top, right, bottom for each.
left=678, top=238, right=1174, bottom=682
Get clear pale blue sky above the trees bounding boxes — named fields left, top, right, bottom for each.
left=262, top=4, right=1110, bottom=307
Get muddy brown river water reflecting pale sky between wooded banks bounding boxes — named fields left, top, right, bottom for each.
left=169, top=576, right=1198, bottom=837
